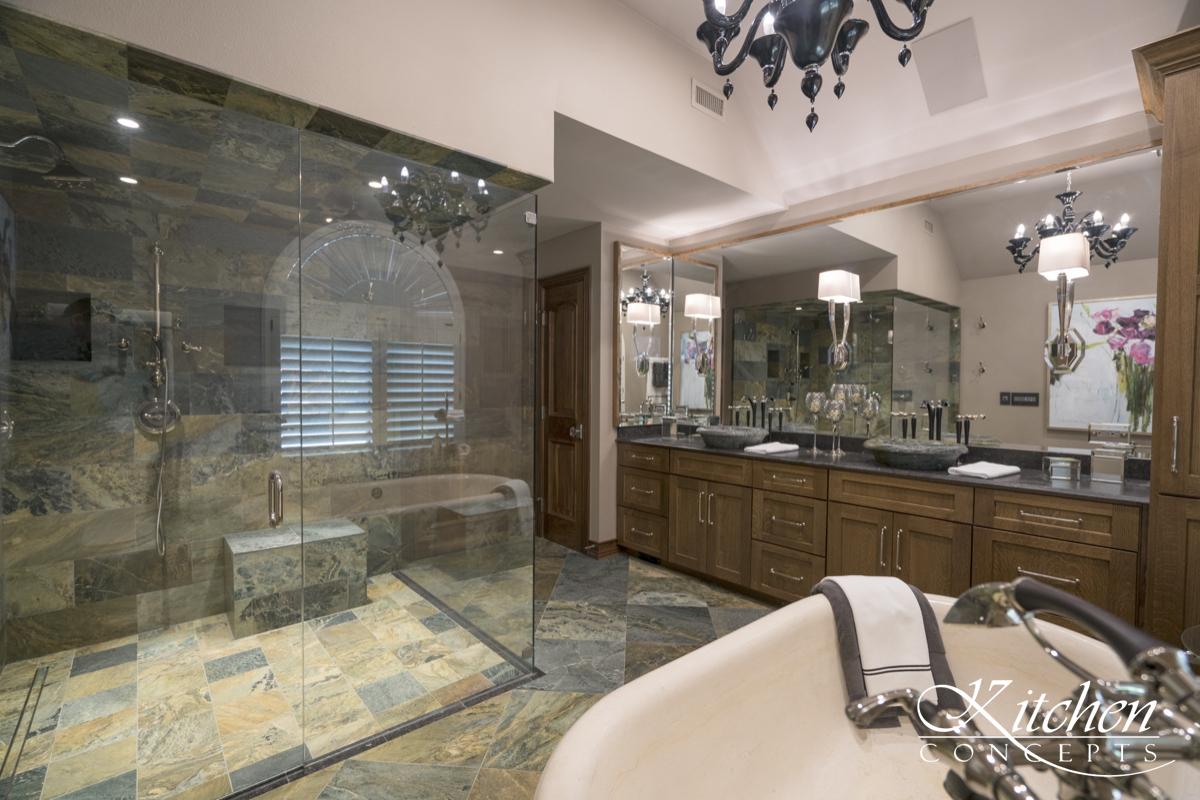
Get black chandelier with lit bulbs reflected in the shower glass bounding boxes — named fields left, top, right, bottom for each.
left=367, top=167, right=492, bottom=253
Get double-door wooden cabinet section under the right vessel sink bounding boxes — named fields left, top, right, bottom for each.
left=828, top=503, right=971, bottom=596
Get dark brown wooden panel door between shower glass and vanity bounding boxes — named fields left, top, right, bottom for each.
left=539, top=270, right=590, bottom=551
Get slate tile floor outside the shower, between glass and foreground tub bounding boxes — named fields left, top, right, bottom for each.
left=264, top=541, right=770, bottom=800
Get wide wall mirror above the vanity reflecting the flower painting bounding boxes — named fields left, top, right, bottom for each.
left=700, top=150, right=1160, bottom=449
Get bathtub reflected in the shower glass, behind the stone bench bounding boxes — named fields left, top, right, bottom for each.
left=330, top=474, right=533, bottom=575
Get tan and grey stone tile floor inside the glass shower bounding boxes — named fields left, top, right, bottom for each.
left=0, top=573, right=529, bottom=800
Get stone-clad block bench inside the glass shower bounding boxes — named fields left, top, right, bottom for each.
left=224, top=519, right=367, bottom=638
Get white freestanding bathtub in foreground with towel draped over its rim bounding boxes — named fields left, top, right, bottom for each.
left=536, top=596, right=1200, bottom=800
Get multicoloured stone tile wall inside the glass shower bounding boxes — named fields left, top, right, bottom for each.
left=0, top=7, right=538, bottom=661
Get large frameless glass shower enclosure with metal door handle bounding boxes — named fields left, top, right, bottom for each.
left=0, top=8, right=536, bottom=800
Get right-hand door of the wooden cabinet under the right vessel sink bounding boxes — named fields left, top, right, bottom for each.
left=892, top=513, right=971, bottom=597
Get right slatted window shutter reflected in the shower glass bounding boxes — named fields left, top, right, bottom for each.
left=385, top=342, right=455, bottom=445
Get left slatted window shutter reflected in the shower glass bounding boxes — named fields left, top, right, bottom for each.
left=280, top=336, right=374, bottom=452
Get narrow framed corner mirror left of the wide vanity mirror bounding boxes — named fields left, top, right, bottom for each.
left=613, top=242, right=721, bottom=427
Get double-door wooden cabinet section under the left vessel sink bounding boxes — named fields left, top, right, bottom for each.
left=667, top=475, right=752, bottom=585
